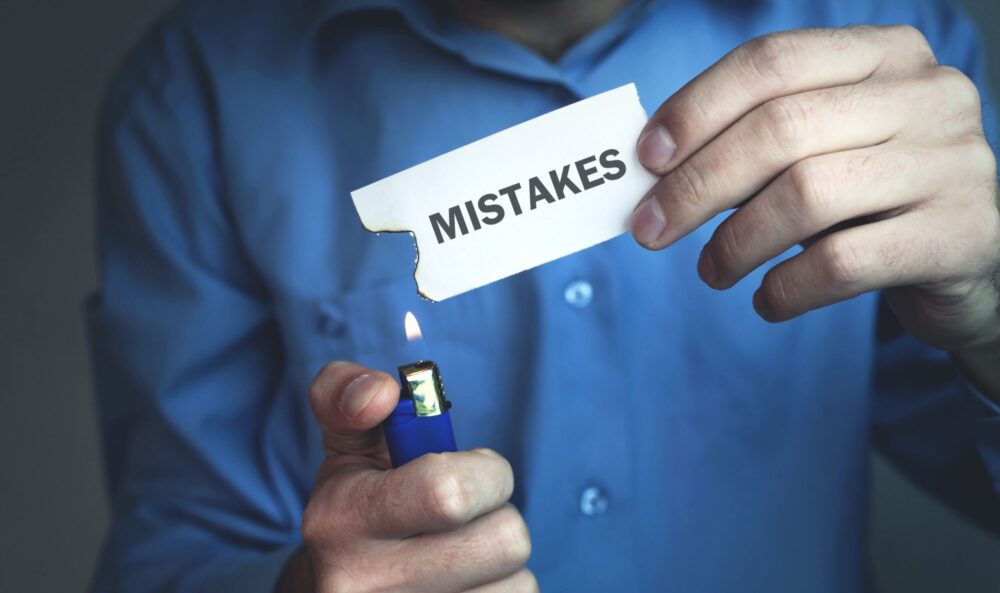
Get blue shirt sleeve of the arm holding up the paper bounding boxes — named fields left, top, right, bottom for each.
left=873, top=0, right=1000, bottom=532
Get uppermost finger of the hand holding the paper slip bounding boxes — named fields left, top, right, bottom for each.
left=637, top=26, right=934, bottom=175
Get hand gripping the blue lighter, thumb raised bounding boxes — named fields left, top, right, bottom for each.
left=277, top=362, right=538, bottom=593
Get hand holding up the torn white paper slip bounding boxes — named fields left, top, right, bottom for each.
left=632, top=26, right=1000, bottom=354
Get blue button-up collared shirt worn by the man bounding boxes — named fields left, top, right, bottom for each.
left=89, top=0, right=1000, bottom=593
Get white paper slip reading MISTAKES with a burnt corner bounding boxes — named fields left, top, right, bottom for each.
left=351, top=84, right=657, bottom=301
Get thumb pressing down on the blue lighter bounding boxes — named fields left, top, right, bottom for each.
left=309, top=361, right=399, bottom=470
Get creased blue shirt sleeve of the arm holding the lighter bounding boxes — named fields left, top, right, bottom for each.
left=87, top=16, right=301, bottom=593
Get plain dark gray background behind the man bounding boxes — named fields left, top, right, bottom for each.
left=0, top=0, right=1000, bottom=593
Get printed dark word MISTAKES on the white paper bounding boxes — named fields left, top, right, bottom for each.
left=429, top=148, right=626, bottom=243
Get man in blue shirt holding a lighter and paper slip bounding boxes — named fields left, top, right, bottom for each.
left=92, top=0, right=1000, bottom=593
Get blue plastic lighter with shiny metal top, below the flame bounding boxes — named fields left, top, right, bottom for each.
left=382, top=360, right=457, bottom=467
